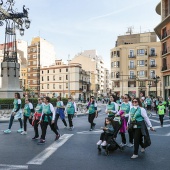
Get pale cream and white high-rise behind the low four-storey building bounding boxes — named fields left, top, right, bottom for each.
left=70, top=50, right=104, bottom=96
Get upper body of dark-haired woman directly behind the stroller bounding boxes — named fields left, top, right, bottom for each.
left=105, top=95, right=118, bottom=117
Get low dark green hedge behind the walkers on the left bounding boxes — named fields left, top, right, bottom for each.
left=0, top=98, right=68, bottom=109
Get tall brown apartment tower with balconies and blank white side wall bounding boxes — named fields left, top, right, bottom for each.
left=27, top=37, right=56, bottom=96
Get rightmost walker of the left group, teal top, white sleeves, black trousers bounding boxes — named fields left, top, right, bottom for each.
left=65, top=97, right=77, bottom=130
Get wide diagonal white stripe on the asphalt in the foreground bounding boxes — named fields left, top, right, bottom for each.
left=27, top=134, right=73, bottom=165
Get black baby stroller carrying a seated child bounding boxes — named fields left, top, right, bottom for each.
left=98, top=117, right=123, bottom=156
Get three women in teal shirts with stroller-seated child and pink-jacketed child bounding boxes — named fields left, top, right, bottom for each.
left=97, top=94, right=154, bottom=159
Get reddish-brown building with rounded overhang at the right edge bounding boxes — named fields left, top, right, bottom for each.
left=155, top=0, right=170, bottom=99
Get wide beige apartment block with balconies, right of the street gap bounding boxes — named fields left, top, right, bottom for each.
left=110, top=32, right=162, bottom=96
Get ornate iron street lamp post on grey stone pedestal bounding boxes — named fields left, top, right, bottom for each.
left=0, top=0, right=31, bottom=98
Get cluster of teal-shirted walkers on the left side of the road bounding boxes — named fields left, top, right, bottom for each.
left=4, top=93, right=77, bottom=145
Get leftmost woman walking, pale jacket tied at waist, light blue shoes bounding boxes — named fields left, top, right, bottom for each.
left=4, top=93, right=23, bottom=134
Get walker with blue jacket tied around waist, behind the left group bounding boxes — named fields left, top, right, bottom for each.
left=55, top=96, right=67, bottom=130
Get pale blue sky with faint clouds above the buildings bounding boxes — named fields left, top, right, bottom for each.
left=0, top=0, right=161, bottom=69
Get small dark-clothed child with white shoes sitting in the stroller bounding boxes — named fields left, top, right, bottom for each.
left=97, top=117, right=114, bottom=147
